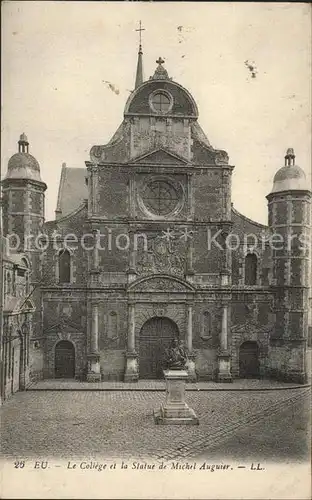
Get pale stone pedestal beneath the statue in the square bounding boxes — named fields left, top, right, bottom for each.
left=154, top=369, right=199, bottom=425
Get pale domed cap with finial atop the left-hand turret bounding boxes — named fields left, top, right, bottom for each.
left=6, top=133, right=42, bottom=182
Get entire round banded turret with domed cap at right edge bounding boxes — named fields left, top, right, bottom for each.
left=267, top=148, right=311, bottom=384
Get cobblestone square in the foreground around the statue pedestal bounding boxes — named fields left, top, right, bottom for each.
left=1, top=388, right=310, bottom=462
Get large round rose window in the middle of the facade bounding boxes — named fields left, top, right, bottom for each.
left=142, top=180, right=180, bottom=216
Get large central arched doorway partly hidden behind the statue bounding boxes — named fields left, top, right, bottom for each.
left=139, top=317, right=179, bottom=379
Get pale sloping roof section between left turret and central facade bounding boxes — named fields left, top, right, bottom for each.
left=56, top=163, right=88, bottom=217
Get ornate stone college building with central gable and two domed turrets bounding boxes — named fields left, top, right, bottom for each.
left=3, top=48, right=311, bottom=383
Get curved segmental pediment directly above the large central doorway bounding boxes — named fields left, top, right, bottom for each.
left=128, top=275, right=195, bottom=293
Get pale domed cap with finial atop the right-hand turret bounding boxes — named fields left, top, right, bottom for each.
left=271, top=148, right=309, bottom=193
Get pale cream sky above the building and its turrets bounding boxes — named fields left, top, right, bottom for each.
left=1, top=1, right=311, bottom=224
